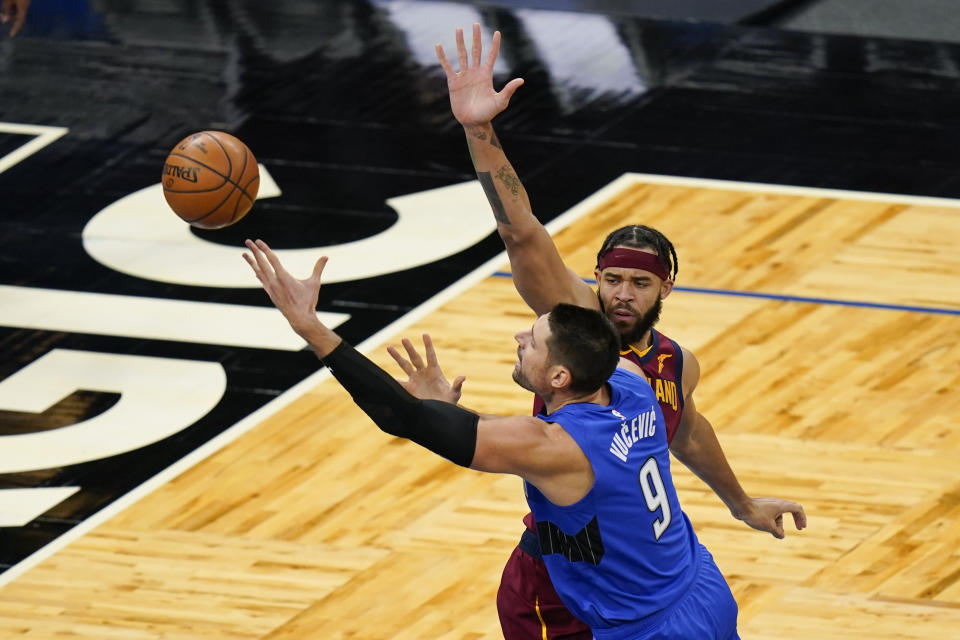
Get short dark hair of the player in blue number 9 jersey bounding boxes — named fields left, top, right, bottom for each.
left=547, top=302, right=620, bottom=393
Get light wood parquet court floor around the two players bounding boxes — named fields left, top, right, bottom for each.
left=0, top=172, right=960, bottom=640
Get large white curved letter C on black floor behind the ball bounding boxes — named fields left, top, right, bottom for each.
left=83, top=170, right=496, bottom=288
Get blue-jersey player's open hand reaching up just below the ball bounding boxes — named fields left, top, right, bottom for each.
left=243, top=240, right=327, bottom=335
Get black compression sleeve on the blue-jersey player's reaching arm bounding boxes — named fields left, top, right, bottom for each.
left=322, top=341, right=480, bottom=467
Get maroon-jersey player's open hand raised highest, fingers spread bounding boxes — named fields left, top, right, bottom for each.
left=436, top=23, right=523, bottom=127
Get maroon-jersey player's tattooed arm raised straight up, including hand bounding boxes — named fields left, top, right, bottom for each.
left=437, top=24, right=599, bottom=315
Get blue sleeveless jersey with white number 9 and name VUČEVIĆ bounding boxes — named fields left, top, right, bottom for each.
left=525, top=369, right=700, bottom=633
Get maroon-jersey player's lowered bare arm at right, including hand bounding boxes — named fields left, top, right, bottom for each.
left=670, top=349, right=807, bottom=538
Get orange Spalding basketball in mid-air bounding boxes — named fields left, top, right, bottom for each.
left=161, top=131, right=260, bottom=229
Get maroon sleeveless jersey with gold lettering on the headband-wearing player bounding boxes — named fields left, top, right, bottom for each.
left=533, top=329, right=683, bottom=443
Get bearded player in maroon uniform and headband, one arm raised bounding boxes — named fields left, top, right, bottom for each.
left=437, top=24, right=806, bottom=640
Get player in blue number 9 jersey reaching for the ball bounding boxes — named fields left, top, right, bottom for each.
left=244, top=240, right=739, bottom=640
